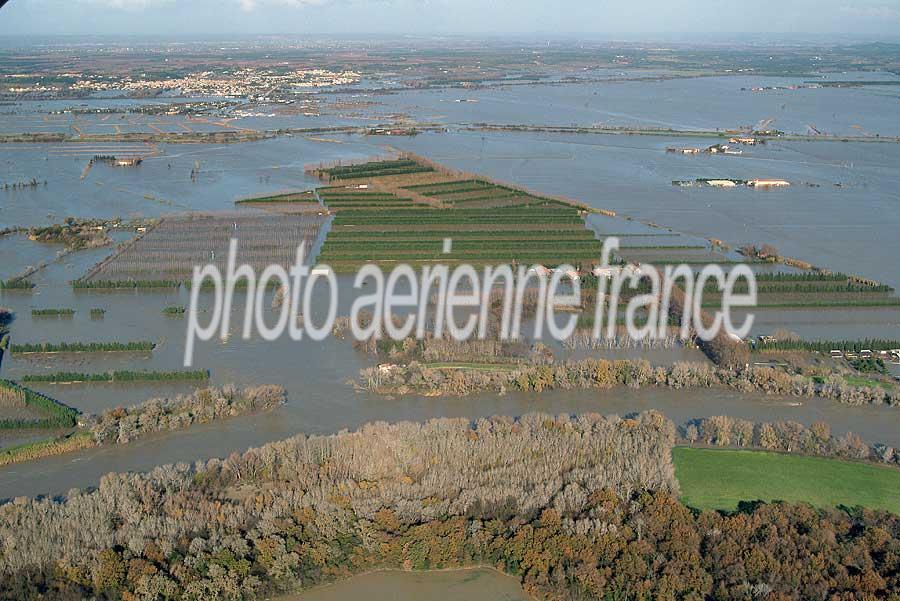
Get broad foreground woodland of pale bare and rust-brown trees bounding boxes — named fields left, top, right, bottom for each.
left=0, top=412, right=900, bottom=601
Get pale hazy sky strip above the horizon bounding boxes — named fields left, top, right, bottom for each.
left=0, top=0, right=900, bottom=42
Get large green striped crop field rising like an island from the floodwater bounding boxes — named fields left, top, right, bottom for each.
left=315, top=159, right=601, bottom=273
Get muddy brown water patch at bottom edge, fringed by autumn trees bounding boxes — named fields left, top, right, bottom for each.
left=276, top=569, right=531, bottom=601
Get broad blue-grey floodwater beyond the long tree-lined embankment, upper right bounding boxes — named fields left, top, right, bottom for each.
left=364, top=73, right=900, bottom=135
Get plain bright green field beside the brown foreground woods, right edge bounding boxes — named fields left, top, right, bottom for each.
left=672, top=447, right=900, bottom=514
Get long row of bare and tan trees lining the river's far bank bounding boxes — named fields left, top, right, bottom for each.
left=360, top=359, right=900, bottom=405
